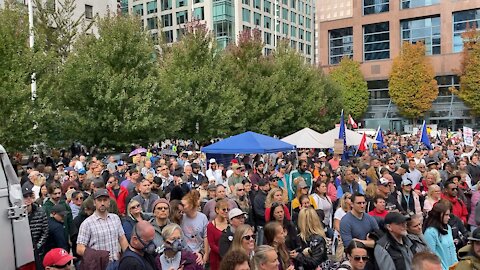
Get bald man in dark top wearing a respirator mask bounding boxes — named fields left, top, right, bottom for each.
left=118, top=220, right=156, bottom=270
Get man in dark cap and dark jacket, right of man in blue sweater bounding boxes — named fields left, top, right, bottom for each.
left=374, top=212, right=413, bottom=270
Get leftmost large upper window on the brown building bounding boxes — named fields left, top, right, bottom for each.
left=330, top=27, right=353, bottom=65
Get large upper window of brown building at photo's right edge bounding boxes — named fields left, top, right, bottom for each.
left=453, top=9, right=480, bottom=53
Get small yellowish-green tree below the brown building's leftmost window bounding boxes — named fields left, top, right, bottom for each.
left=330, top=57, right=368, bottom=119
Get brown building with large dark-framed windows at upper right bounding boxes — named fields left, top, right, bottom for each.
left=317, top=0, right=480, bottom=130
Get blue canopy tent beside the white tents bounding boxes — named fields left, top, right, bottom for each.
left=201, top=131, right=295, bottom=154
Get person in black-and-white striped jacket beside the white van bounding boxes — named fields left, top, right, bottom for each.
left=22, top=187, right=48, bottom=269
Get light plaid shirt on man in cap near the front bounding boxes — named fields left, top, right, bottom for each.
left=77, top=212, right=125, bottom=261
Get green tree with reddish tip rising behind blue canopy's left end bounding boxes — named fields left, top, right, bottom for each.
left=159, top=25, right=243, bottom=141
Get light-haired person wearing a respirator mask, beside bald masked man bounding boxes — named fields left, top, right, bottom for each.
left=155, top=223, right=203, bottom=270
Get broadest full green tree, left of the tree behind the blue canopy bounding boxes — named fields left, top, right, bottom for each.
left=48, top=16, right=166, bottom=146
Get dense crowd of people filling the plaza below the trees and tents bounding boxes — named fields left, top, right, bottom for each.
left=16, top=134, right=480, bottom=270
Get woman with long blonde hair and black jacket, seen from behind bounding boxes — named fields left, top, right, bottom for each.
left=290, top=207, right=328, bottom=269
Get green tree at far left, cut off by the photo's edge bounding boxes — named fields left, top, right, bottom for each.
left=0, top=1, right=37, bottom=151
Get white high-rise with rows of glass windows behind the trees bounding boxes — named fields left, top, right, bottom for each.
left=128, top=0, right=315, bottom=63
